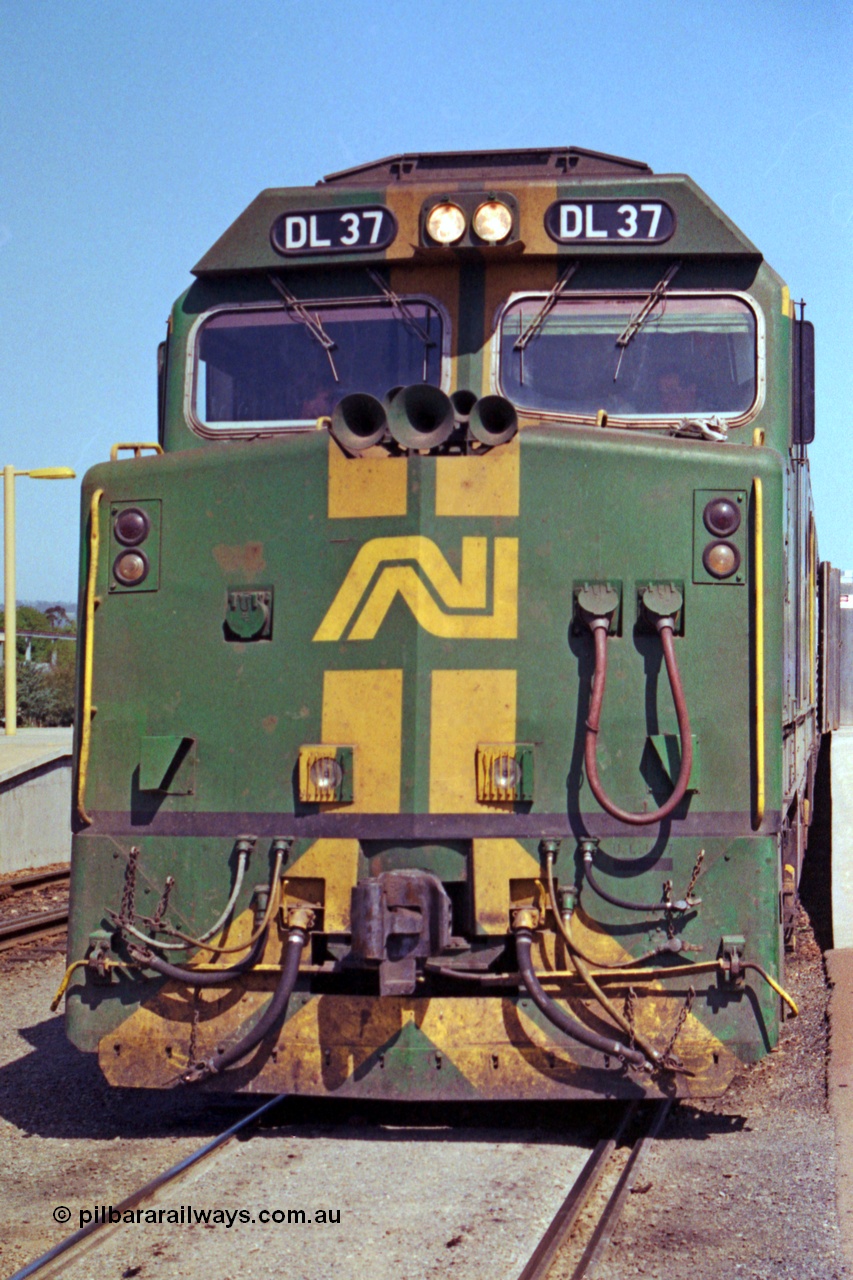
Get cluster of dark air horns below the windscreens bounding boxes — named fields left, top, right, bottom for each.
left=330, top=383, right=519, bottom=453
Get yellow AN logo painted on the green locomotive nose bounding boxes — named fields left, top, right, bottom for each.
left=314, top=535, right=519, bottom=640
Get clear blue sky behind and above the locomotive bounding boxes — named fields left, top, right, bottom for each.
left=0, top=0, right=853, bottom=599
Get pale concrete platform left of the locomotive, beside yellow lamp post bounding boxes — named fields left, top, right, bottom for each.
left=0, top=728, right=73, bottom=876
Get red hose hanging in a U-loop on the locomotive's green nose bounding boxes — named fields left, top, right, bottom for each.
left=584, top=617, right=693, bottom=827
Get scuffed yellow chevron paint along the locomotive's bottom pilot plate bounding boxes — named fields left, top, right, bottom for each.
left=99, top=972, right=739, bottom=1098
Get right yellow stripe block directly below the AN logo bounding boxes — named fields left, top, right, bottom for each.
left=429, top=669, right=516, bottom=813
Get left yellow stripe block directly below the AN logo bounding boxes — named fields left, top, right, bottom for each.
left=321, top=668, right=402, bottom=813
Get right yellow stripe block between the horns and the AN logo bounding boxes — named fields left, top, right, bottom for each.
left=435, top=435, right=521, bottom=516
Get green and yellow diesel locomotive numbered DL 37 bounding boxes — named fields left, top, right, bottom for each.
left=64, top=147, right=827, bottom=1100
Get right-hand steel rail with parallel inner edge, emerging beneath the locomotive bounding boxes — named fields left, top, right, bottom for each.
left=514, top=1098, right=671, bottom=1280
